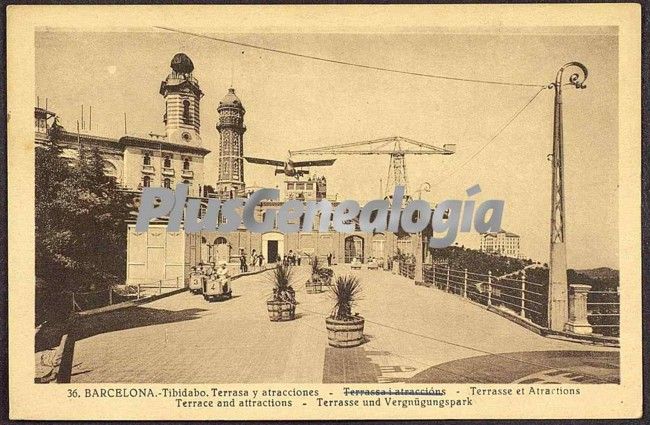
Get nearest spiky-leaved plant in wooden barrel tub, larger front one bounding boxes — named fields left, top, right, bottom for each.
left=325, top=275, right=364, bottom=348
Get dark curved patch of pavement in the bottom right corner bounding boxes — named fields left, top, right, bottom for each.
left=406, top=351, right=620, bottom=384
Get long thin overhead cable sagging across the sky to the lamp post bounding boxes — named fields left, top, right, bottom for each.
left=154, top=26, right=548, bottom=88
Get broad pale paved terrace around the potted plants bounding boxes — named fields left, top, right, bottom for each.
left=72, top=265, right=618, bottom=383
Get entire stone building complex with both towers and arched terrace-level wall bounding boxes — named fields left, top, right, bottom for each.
left=35, top=53, right=415, bottom=284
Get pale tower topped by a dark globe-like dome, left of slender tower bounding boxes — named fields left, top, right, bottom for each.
left=160, top=53, right=203, bottom=146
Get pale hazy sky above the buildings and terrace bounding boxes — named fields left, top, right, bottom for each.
left=35, top=27, right=618, bottom=268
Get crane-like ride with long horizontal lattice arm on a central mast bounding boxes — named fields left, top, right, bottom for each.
left=289, top=136, right=456, bottom=199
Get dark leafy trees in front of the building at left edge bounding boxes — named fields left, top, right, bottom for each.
left=35, top=123, right=130, bottom=320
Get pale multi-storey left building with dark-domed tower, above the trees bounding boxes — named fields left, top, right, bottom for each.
left=34, top=53, right=210, bottom=196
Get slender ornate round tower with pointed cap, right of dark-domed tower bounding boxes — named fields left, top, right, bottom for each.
left=216, top=88, right=246, bottom=196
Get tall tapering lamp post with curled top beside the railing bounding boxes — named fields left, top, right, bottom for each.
left=548, top=62, right=587, bottom=331
